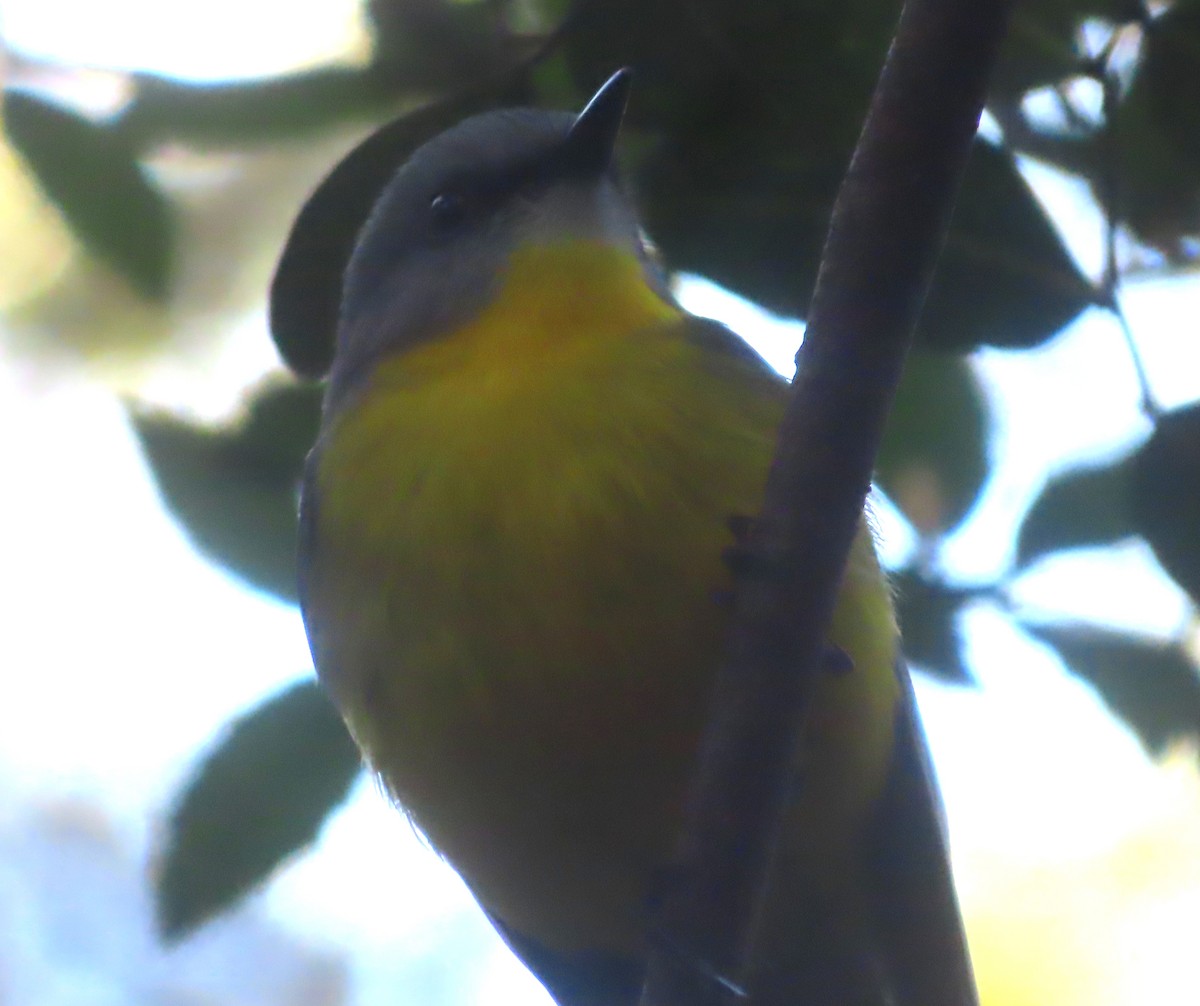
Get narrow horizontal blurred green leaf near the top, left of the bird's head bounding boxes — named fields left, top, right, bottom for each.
left=122, top=67, right=398, bottom=149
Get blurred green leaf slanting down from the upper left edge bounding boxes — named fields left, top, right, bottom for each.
left=4, top=91, right=174, bottom=299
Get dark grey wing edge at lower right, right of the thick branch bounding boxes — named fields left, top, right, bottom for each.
left=868, top=660, right=979, bottom=1006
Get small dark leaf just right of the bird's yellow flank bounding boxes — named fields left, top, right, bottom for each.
left=888, top=569, right=979, bottom=684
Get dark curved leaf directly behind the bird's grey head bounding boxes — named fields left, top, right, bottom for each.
left=270, top=91, right=499, bottom=378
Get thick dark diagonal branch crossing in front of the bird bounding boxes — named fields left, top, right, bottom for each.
left=642, top=0, right=1013, bottom=1006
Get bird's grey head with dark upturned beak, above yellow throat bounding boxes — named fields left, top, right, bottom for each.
left=326, top=70, right=658, bottom=408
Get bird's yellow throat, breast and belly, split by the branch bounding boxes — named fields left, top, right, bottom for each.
left=306, top=242, right=896, bottom=952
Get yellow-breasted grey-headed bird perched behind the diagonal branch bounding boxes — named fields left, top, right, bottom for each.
left=290, top=70, right=976, bottom=1006
